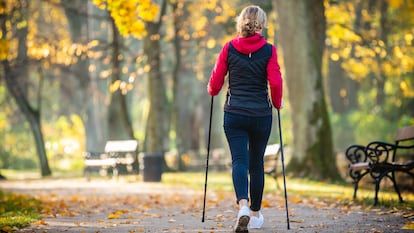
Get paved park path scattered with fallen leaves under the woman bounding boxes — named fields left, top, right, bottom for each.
left=0, top=179, right=414, bottom=233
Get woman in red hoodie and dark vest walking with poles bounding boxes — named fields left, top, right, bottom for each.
left=207, top=5, right=282, bottom=232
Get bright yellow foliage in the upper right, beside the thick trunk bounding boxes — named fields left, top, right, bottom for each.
left=325, top=0, right=414, bottom=87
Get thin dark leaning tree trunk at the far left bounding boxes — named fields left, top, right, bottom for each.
left=0, top=0, right=52, bottom=177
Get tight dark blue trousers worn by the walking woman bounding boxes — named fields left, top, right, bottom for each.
left=224, top=112, right=272, bottom=211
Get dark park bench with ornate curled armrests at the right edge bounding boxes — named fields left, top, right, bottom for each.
left=345, top=125, right=414, bottom=205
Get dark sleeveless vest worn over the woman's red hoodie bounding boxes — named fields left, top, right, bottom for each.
left=224, top=43, right=272, bottom=116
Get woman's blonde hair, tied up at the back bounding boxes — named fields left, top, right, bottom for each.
left=236, top=5, right=267, bottom=37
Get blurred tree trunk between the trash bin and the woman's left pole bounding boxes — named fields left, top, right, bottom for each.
left=171, top=2, right=201, bottom=170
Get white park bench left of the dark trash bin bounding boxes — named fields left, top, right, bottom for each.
left=84, top=140, right=138, bottom=179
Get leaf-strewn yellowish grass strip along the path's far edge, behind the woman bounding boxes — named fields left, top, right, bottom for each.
left=162, top=172, right=414, bottom=211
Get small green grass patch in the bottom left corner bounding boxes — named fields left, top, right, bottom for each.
left=0, top=191, right=41, bottom=232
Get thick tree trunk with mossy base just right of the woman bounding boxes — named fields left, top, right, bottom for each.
left=276, top=0, right=340, bottom=180
